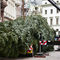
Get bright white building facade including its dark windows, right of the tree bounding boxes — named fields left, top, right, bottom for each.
left=41, top=0, right=60, bottom=32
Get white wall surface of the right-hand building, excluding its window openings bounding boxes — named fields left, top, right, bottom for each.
left=41, top=0, right=60, bottom=31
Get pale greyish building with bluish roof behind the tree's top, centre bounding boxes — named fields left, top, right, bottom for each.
left=28, top=0, right=41, bottom=15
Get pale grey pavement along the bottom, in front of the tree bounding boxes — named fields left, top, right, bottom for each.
left=0, top=51, right=60, bottom=60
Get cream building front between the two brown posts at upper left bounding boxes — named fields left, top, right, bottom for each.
left=4, top=0, right=20, bottom=20
